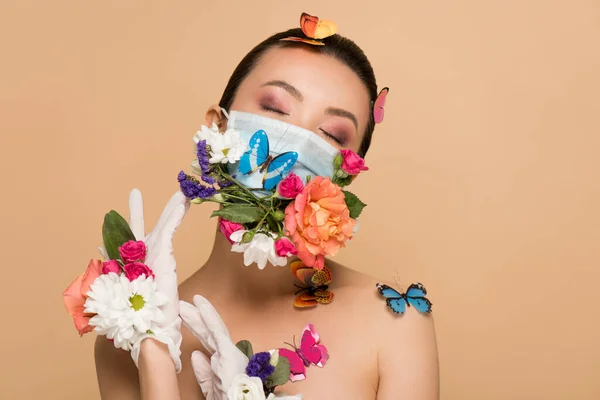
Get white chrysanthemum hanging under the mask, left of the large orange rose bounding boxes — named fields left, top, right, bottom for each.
left=229, top=230, right=287, bottom=269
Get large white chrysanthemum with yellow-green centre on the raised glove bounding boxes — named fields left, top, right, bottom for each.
left=84, top=272, right=168, bottom=350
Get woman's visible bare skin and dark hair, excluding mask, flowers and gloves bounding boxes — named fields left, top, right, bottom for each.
left=90, top=18, right=438, bottom=400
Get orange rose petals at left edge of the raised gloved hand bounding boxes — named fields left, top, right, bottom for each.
left=63, top=260, right=102, bottom=336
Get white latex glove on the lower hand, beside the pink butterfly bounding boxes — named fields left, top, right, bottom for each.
left=179, top=295, right=302, bottom=400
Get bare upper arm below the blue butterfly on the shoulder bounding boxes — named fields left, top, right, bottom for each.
left=377, top=308, right=439, bottom=400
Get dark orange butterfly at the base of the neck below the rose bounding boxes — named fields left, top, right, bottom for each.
left=290, top=261, right=334, bottom=308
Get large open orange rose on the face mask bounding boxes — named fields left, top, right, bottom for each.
left=285, top=176, right=356, bottom=270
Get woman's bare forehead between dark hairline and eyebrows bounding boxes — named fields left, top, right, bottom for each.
left=238, top=46, right=370, bottom=131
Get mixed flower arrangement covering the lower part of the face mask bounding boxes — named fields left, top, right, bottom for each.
left=178, top=124, right=368, bottom=270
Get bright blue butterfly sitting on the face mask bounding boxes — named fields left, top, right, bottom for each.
left=239, top=130, right=298, bottom=190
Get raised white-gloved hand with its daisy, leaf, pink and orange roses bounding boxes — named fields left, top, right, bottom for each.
left=63, top=190, right=187, bottom=371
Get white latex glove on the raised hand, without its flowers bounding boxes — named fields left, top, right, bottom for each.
left=100, top=189, right=190, bottom=373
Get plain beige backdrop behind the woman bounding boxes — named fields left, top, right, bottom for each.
left=0, top=0, right=600, bottom=400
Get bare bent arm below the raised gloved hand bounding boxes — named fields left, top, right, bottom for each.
left=95, top=336, right=181, bottom=400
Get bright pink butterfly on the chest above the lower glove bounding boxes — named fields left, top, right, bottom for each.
left=279, top=324, right=329, bottom=382
